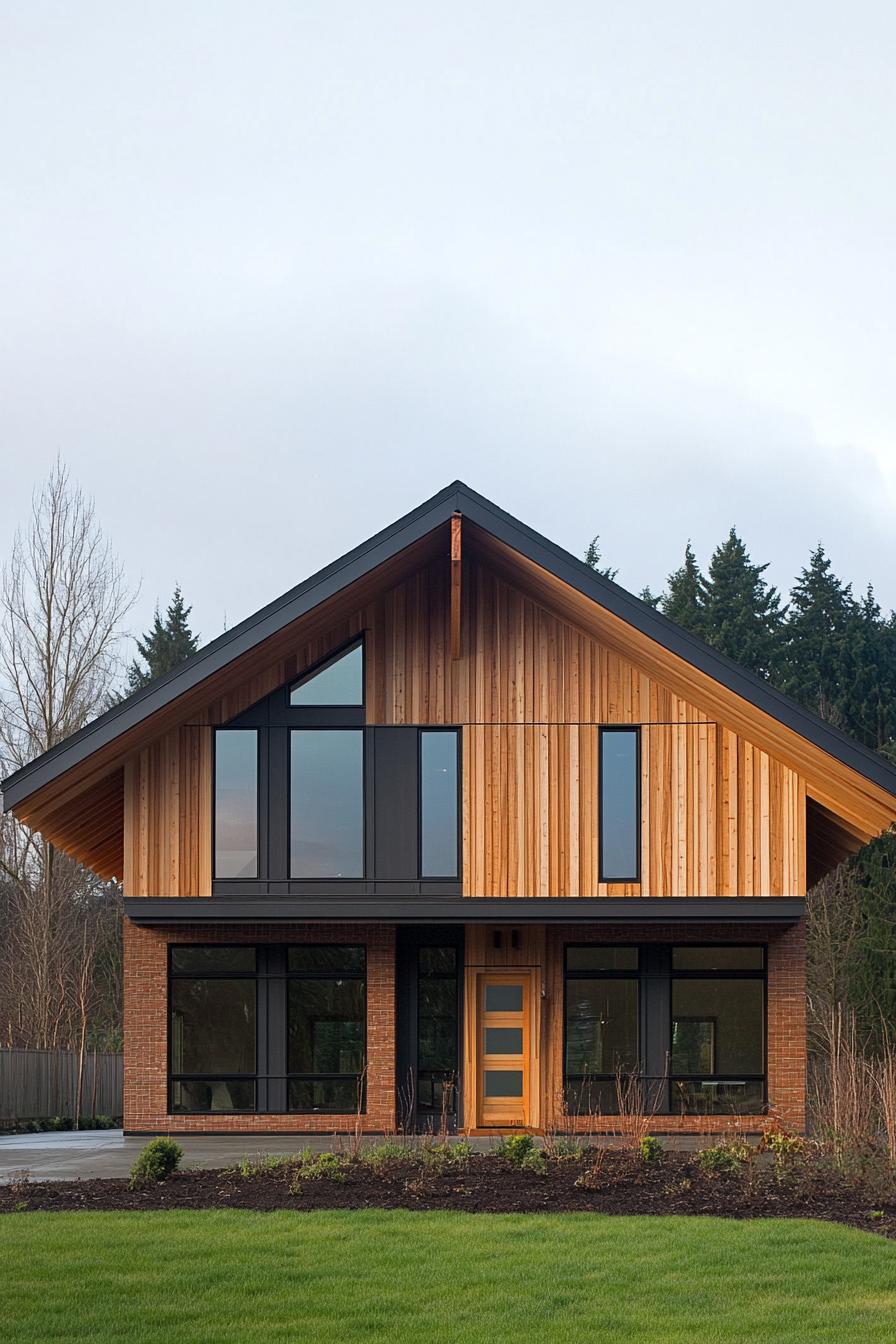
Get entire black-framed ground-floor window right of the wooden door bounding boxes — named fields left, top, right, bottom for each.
left=564, top=945, right=766, bottom=1114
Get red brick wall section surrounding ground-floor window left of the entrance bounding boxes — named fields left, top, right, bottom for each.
left=124, top=919, right=395, bottom=1134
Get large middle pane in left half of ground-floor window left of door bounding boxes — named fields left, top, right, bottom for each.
left=171, top=980, right=255, bottom=1074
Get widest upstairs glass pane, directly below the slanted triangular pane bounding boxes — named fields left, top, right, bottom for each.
left=290, top=728, right=364, bottom=878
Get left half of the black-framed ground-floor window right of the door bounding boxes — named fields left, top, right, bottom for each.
left=563, top=943, right=641, bottom=1116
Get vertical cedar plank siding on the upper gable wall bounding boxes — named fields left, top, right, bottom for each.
left=124, top=552, right=806, bottom=898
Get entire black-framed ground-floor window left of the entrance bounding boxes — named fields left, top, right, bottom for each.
left=168, top=945, right=367, bottom=1114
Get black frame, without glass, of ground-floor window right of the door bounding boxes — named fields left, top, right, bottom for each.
left=562, top=938, right=768, bottom=1117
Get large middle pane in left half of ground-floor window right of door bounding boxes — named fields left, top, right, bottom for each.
left=566, top=980, right=638, bottom=1074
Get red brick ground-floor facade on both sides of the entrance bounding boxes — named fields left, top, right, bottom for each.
left=125, top=919, right=806, bottom=1134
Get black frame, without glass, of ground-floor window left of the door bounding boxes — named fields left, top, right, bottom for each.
left=165, top=938, right=369, bottom=1117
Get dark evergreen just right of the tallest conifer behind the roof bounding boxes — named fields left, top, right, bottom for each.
left=775, top=542, right=857, bottom=726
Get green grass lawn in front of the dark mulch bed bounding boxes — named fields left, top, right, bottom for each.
left=0, top=1210, right=896, bottom=1344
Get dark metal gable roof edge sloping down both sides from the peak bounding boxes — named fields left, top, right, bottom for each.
left=3, top=481, right=896, bottom=810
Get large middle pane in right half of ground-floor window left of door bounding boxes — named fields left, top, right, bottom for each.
left=286, top=980, right=365, bottom=1074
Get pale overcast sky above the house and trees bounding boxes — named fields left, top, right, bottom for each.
left=0, top=0, right=896, bottom=658
